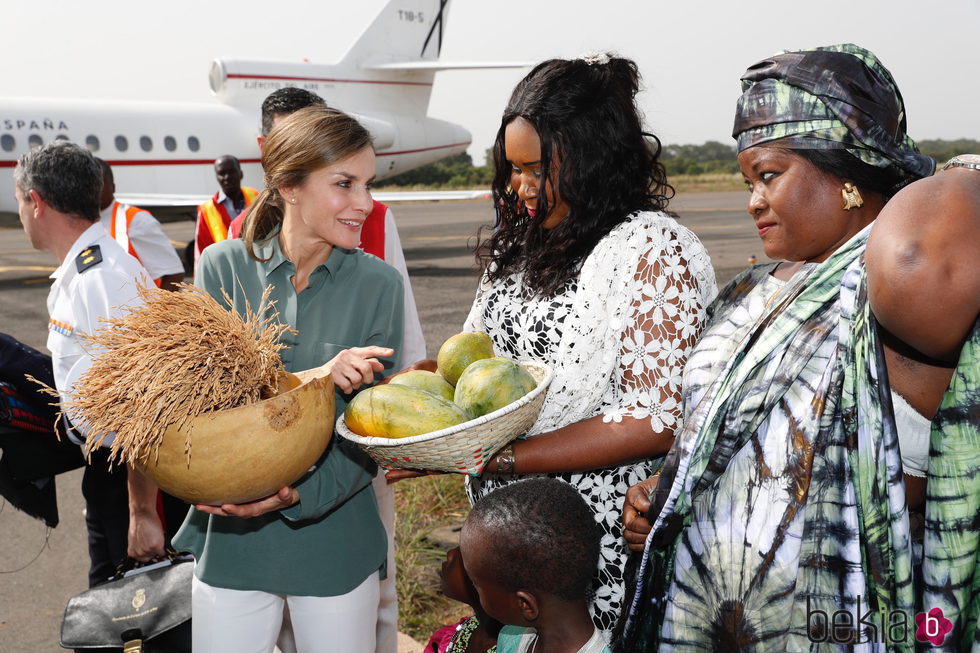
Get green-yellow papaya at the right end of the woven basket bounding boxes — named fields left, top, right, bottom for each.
left=453, top=358, right=538, bottom=417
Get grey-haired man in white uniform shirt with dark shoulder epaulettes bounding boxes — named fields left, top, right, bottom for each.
left=14, top=141, right=164, bottom=586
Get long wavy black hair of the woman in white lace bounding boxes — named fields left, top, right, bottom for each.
left=476, top=55, right=674, bottom=296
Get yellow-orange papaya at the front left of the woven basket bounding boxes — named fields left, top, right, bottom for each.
left=344, top=383, right=472, bottom=438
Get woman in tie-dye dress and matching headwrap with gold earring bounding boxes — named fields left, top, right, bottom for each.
left=618, top=45, right=980, bottom=652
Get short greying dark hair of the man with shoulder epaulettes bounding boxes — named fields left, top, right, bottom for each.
left=14, top=140, right=102, bottom=222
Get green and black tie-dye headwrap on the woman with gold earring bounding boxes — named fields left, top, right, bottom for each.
left=732, top=43, right=935, bottom=185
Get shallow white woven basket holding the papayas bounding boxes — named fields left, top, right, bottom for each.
left=337, top=361, right=554, bottom=474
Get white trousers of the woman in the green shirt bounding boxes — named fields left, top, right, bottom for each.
left=191, top=572, right=379, bottom=653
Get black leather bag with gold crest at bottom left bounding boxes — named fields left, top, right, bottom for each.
left=59, top=551, right=194, bottom=653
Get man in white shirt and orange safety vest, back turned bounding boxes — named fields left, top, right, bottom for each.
left=96, top=157, right=184, bottom=290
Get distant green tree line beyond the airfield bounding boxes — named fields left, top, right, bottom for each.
left=377, top=138, right=980, bottom=189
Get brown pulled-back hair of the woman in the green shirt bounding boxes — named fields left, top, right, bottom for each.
left=242, top=106, right=371, bottom=261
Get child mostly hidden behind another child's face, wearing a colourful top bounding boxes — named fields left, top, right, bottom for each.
left=425, top=546, right=500, bottom=653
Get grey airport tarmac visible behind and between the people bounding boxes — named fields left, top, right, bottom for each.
left=0, top=192, right=765, bottom=653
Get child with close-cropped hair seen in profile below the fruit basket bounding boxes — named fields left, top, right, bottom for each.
left=460, top=478, right=609, bottom=653
